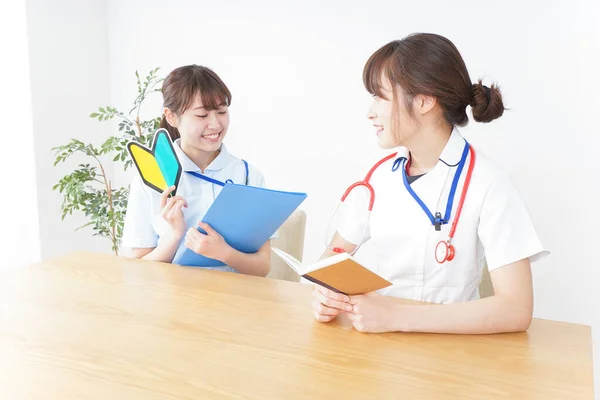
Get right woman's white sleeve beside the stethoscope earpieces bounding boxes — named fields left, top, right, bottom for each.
left=328, top=186, right=371, bottom=245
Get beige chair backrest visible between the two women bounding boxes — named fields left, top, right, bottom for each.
left=267, top=210, right=306, bottom=282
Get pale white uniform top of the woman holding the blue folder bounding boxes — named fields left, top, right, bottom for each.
left=121, top=139, right=265, bottom=271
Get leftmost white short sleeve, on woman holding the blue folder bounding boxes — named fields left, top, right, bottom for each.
left=121, top=174, right=158, bottom=248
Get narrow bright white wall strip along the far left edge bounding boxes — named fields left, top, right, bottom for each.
left=0, top=0, right=40, bottom=268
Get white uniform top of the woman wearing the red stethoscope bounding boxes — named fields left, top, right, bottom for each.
left=337, top=129, right=547, bottom=303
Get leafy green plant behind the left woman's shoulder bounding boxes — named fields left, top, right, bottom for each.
left=52, top=68, right=163, bottom=255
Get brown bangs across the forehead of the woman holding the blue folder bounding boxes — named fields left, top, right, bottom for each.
left=180, top=67, right=231, bottom=113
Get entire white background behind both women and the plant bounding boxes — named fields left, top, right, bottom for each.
left=0, top=0, right=600, bottom=394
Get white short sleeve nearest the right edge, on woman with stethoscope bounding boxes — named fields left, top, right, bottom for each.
left=478, top=175, right=548, bottom=271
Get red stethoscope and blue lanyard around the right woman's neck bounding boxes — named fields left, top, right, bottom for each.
left=325, top=141, right=475, bottom=264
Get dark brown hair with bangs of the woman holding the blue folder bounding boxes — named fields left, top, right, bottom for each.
left=160, top=64, right=231, bottom=140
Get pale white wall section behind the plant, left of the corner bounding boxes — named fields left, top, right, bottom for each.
left=27, top=0, right=112, bottom=258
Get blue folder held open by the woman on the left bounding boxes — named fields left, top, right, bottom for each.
left=173, top=183, right=306, bottom=267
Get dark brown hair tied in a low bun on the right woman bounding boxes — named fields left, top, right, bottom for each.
left=363, top=33, right=504, bottom=130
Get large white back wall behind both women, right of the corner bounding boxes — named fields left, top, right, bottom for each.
left=108, top=0, right=600, bottom=388
